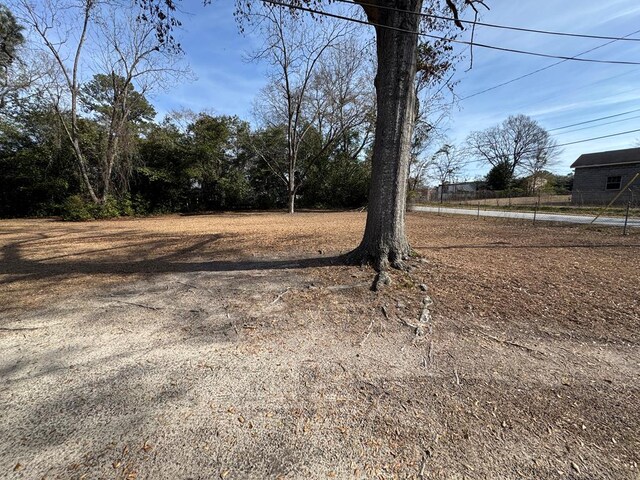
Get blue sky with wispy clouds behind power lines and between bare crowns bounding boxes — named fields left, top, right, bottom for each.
left=154, top=0, right=640, bottom=177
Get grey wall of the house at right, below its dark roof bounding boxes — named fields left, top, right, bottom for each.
left=571, top=163, right=640, bottom=205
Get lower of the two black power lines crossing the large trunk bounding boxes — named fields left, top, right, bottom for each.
left=262, top=0, right=640, bottom=65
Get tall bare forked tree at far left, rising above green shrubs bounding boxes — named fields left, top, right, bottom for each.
left=19, top=0, right=184, bottom=203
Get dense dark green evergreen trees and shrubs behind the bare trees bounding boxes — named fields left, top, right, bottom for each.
left=0, top=102, right=369, bottom=220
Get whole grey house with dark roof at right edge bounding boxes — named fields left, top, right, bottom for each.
left=571, top=148, right=640, bottom=205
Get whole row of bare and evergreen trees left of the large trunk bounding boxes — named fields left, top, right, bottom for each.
left=0, top=0, right=375, bottom=220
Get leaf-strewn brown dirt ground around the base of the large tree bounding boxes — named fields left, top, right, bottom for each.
left=0, top=212, right=640, bottom=480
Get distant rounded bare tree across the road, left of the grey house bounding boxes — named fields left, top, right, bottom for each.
left=466, top=115, right=559, bottom=177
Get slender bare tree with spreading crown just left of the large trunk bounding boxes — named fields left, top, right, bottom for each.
left=255, top=7, right=372, bottom=213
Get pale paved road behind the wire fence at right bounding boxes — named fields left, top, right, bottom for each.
left=411, top=205, right=640, bottom=227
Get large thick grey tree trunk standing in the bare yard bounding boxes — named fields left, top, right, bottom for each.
left=349, top=0, right=422, bottom=270
